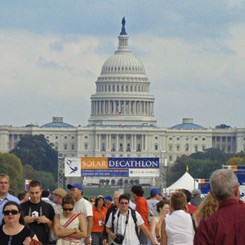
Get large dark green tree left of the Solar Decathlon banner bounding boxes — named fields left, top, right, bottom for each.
left=11, top=135, right=58, bottom=177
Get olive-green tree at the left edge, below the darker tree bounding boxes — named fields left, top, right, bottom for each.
left=0, top=153, right=25, bottom=195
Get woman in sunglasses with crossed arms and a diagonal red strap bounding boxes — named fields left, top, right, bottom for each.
left=54, top=194, right=87, bottom=245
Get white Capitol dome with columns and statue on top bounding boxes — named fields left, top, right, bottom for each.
left=89, top=18, right=156, bottom=127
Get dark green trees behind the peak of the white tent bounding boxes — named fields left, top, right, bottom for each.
left=167, top=148, right=231, bottom=186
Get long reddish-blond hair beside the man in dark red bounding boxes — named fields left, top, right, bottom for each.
left=194, top=193, right=218, bottom=222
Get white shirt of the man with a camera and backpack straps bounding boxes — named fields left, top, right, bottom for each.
left=106, top=209, right=144, bottom=245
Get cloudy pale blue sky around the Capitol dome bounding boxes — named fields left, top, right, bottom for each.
left=0, top=0, right=245, bottom=127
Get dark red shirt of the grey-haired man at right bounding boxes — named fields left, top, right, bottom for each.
left=194, top=199, right=245, bottom=245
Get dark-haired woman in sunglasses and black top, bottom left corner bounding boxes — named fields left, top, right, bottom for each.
left=0, top=201, right=38, bottom=245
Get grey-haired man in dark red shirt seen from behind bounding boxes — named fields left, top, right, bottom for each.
left=194, top=169, right=245, bottom=245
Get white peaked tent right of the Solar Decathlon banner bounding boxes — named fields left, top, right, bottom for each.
left=166, top=172, right=198, bottom=193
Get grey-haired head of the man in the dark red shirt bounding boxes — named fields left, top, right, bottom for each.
left=209, top=169, right=240, bottom=202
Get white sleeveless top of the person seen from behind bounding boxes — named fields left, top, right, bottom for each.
left=166, top=210, right=195, bottom=245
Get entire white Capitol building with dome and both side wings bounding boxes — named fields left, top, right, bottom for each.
left=0, top=22, right=245, bottom=184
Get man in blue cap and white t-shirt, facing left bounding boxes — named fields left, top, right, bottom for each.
left=67, top=183, right=93, bottom=245
